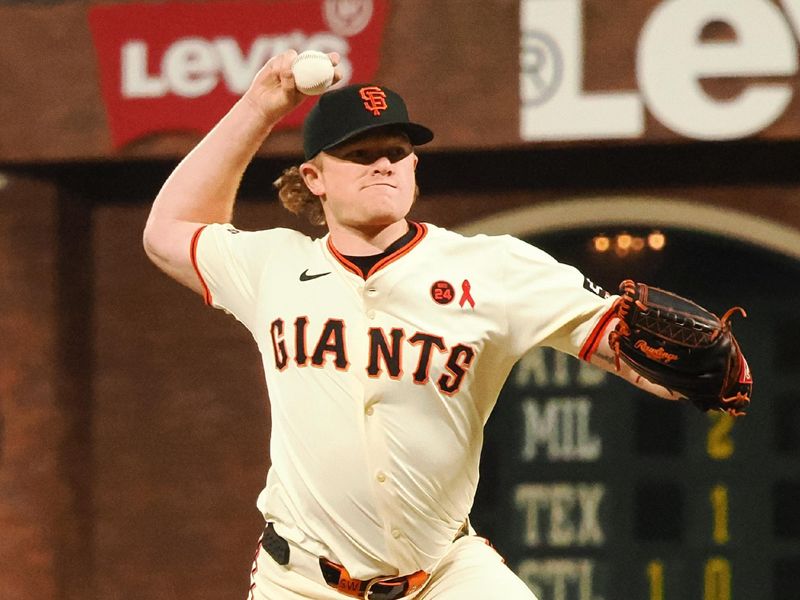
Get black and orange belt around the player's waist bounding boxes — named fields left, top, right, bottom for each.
left=261, top=521, right=469, bottom=600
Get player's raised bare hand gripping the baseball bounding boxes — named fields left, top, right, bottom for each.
left=244, top=50, right=342, bottom=125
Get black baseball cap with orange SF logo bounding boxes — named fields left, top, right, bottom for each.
left=303, top=83, right=433, bottom=160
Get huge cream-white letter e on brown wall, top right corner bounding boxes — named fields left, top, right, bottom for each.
left=636, top=0, right=797, bottom=140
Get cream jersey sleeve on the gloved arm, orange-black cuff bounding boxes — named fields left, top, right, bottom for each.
left=502, top=236, right=616, bottom=361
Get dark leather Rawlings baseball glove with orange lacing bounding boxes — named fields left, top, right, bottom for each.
left=608, top=279, right=753, bottom=416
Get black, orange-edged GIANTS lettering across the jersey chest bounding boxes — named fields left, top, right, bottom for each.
left=269, top=317, right=475, bottom=396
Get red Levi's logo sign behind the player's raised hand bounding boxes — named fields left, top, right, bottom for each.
left=89, top=0, right=389, bottom=148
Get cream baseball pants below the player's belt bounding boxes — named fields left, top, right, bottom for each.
left=248, top=535, right=536, bottom=600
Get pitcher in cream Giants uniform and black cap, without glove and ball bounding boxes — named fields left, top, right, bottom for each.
left=144, top=51, right=752, bottom=600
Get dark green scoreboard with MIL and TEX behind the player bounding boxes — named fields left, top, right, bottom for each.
left=473, top=234, right=800, bottom=600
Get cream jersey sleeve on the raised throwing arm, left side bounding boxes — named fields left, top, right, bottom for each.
left=191, top=223, right=301, bottom=331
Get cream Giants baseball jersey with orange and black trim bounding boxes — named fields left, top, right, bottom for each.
left=192, top=223, right=613, bottom=579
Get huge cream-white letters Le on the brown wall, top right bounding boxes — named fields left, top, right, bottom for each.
left=520, top=0, right=800, bottom=140
